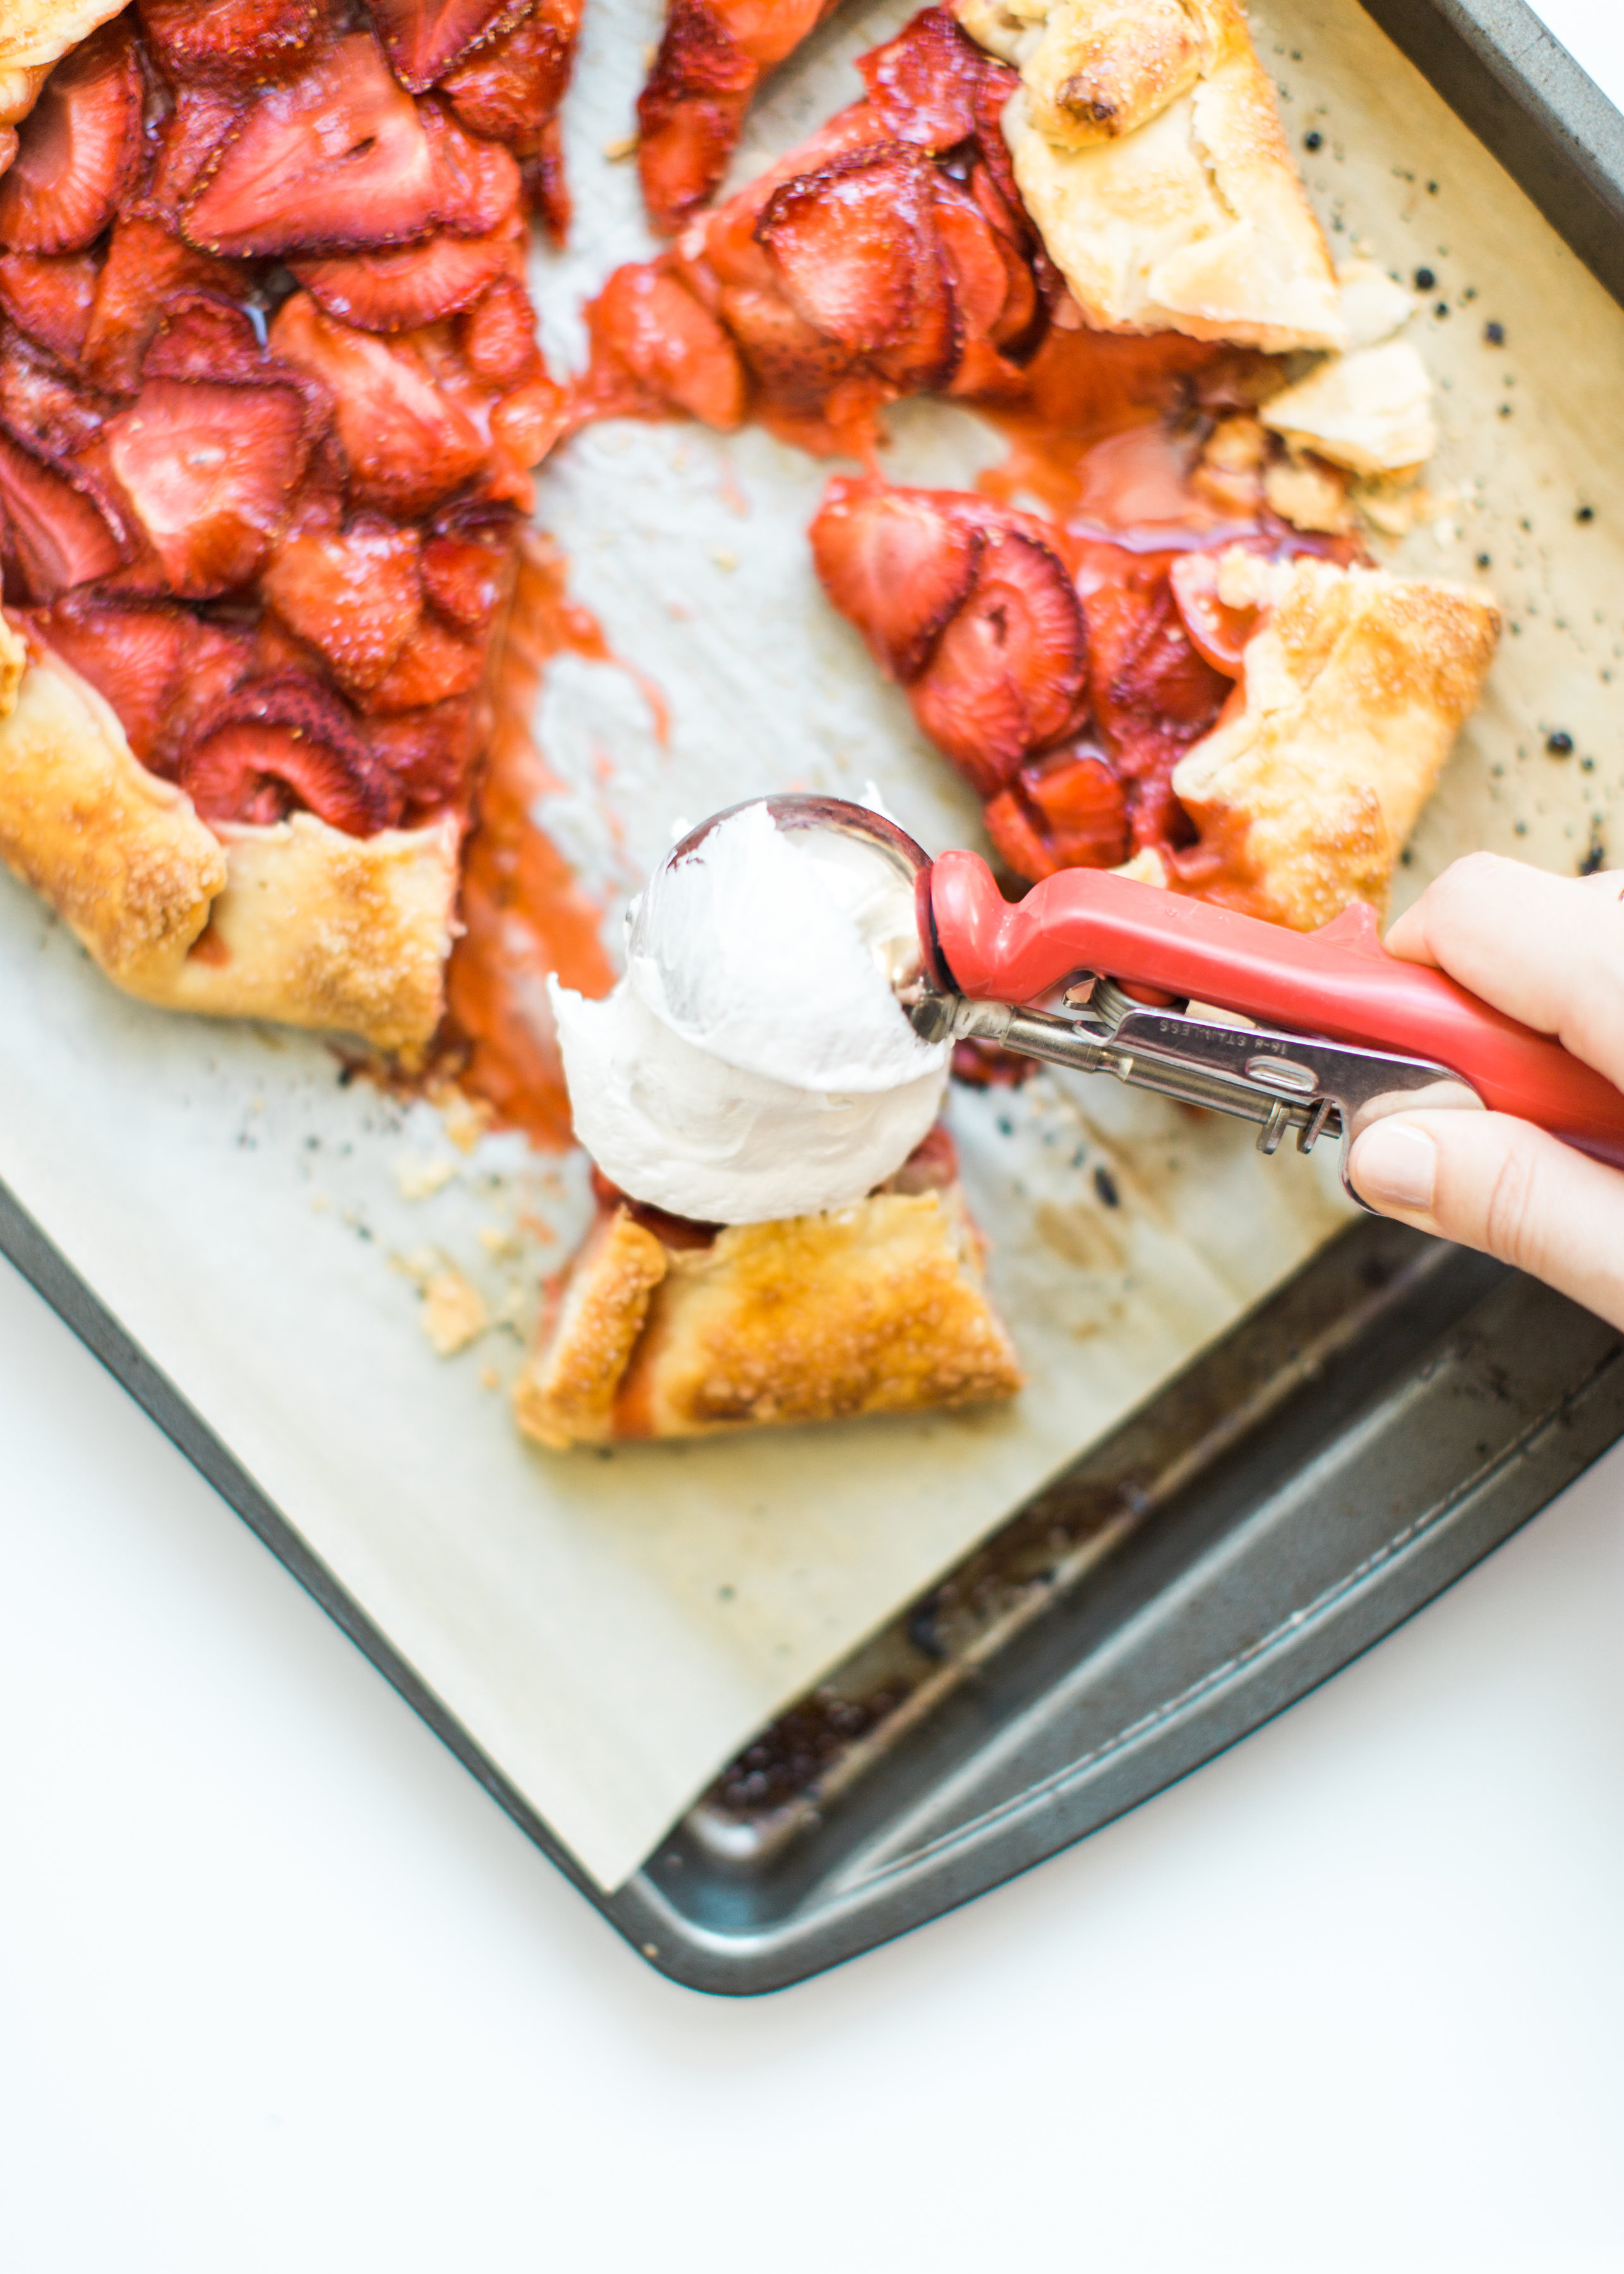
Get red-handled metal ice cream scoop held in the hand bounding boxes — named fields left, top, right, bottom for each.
left=587, top=796, right=1624, bottom=1205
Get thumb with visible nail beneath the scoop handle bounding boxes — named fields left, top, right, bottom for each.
left=1349, top=1112, right=1624, bottom=1328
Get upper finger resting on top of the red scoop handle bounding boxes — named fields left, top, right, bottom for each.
left=1388, top=853, right=1624, bottom=1087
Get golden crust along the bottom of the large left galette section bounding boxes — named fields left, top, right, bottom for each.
left=0, top=621, right=459, bottom=1050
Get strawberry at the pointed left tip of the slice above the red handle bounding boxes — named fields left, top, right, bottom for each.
left=812, top=475, right=987, bottom=685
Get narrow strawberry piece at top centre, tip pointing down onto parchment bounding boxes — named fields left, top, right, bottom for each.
left=637, top=0, right=762, bottom=236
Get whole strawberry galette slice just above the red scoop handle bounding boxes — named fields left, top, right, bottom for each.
left=812, top=478, right=1499, bottom=930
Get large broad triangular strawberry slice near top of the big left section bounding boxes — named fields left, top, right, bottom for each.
left=184, top=32, right=438, bottom=257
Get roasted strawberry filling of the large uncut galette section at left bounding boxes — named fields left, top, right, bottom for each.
left=0, top=0, right=578, bottom=834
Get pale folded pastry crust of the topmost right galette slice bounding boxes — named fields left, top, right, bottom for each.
left=955, top=0, right=1349, bottom=352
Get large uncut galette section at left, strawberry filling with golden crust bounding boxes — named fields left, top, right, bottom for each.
left=0, top=0, right=575, bottom=1050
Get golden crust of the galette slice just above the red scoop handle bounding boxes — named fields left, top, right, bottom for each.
left=1155, top=553, right=1501, bottom=930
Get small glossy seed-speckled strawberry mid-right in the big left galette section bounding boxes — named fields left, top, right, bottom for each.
left=262, top=514, right=423, bottom=696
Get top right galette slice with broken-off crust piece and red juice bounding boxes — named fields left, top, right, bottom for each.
left=575, top=0, right=1433, bottom=532
